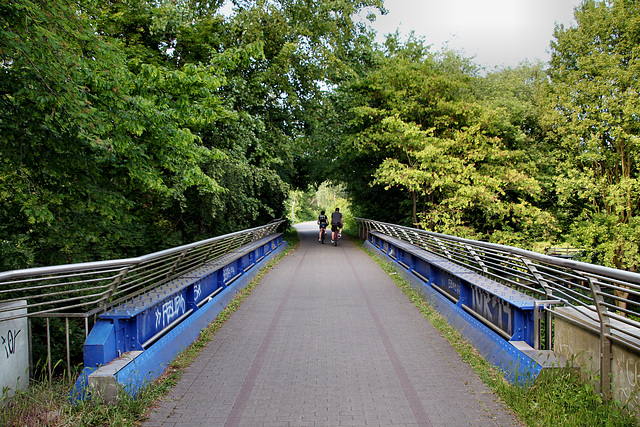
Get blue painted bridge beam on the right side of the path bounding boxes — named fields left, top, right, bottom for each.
left=365, top=231, right=568, bottom=385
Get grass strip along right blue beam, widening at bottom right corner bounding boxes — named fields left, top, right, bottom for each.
left=363, top=242, right=639, bottom=427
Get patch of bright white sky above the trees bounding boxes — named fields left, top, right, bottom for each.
left=362, top=0, right=580, bottom=70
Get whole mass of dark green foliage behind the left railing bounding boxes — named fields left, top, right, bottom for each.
left=0, top=0, right=382, bottom=270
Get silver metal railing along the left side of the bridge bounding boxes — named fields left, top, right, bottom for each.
left=0, top=220, right=285, bottom=378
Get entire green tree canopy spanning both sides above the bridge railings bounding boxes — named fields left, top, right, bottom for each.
left=0, top=0, right=640, bottom=271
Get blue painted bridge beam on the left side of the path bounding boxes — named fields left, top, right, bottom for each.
left=70, top=233, right=287, bottom=401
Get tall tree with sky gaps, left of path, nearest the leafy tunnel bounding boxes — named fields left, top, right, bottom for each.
left=166, top=0, right=381, bottom=234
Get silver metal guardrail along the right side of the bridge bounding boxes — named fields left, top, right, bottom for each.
left=355, top=218, right=640, bottom=400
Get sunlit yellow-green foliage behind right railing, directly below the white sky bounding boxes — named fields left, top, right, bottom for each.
left=336, top=35, right=554, bottom=244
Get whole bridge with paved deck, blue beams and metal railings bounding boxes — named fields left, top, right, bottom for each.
left=0, top=219, right=640, bottom=426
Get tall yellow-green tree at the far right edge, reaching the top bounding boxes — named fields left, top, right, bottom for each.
left=545, top=0, right=640, bottom=271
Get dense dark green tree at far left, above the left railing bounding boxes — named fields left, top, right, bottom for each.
left=0, top=0, right=224, bottom=269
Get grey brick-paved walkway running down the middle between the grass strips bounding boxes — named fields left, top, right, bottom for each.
left=143, top=223, right=520, bottom=427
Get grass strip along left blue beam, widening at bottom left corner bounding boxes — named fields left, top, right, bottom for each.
left=0, top=230, right=299, bottom=427
